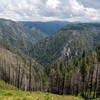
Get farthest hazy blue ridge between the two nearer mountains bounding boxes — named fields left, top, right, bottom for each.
left=19, top=21, right=71, bottom=34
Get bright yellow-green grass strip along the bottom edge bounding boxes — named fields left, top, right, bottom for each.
left=0, top=90, right=83, bottom=100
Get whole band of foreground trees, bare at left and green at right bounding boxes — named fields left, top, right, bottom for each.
left=0, top=46, right=100, bottom=99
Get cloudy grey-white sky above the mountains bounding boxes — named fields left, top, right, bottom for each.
left=0, top=0, right=100, bottom=22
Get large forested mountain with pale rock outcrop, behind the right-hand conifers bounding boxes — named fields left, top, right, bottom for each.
left=31, top=24, right=100, bottom=65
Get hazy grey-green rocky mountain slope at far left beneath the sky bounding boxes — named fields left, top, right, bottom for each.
left=0, top=19, right=46, bottom=51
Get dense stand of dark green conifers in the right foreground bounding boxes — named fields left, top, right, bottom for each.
left=46, top=46, right=100, bottom=99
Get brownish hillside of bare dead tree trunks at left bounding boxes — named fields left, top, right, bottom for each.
left=0, top=42, right=46, bottom=91
